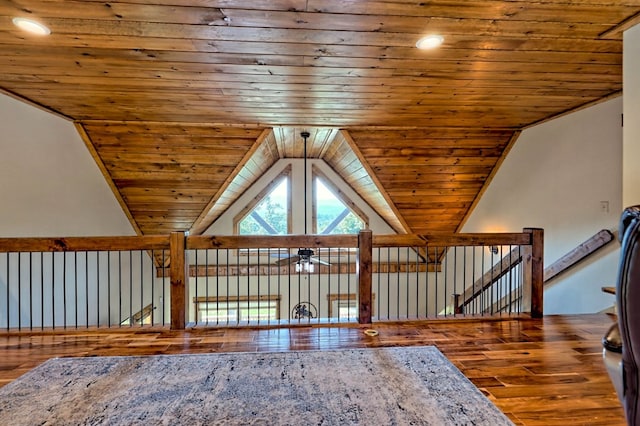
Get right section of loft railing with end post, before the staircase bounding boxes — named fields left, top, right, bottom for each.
left=375, top=228, right=544, bottom=319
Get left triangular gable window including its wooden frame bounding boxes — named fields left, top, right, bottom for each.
left=234, top=168, right=291, bottom=235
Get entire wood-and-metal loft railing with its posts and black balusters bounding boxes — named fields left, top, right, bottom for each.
left=0, top=229, right=543, bottom=331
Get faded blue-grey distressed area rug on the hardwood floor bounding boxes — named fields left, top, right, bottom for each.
left=0, top=346, right=512, bottom=426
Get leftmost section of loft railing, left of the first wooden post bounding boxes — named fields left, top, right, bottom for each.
left=0, top=236, right=169, bottom=330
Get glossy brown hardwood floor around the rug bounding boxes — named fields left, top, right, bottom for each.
left=0, top=314, right=625, bottom=426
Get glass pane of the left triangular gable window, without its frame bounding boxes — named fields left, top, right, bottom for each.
left=239, top=178, right=289, bottom=235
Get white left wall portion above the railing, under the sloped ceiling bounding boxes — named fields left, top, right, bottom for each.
left=0, top=94, right=135, bottom=237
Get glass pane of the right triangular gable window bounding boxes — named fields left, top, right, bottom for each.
left=316, top=177, right=364, bottom=234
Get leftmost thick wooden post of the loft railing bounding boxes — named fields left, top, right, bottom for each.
left=169, top=232, right=189, bottom=330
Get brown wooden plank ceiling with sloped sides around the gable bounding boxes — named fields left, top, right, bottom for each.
left=0, top=0, right=640, bottom=234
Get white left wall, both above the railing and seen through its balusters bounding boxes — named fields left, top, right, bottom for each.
left=0, top=94, right=149, bottom=328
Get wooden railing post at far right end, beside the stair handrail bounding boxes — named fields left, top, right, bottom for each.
left=523, top=228, right=544, bottom=318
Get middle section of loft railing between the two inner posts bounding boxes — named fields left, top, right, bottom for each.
left=181, top=232, right=360, bottom=328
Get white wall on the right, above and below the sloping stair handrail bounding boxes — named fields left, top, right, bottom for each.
left=463, top=98, right=624, bottom=314
